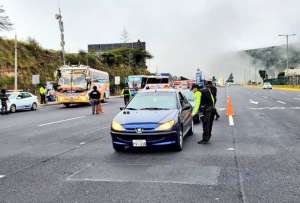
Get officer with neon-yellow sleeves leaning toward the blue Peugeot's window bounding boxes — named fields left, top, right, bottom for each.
left=192, top=85, right=215, bottom=144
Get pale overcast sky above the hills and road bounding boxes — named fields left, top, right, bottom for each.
left=0, top=0, right=300, bottom=81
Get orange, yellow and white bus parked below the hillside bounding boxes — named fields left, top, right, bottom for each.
left=56, top=65, right=110, bottom=107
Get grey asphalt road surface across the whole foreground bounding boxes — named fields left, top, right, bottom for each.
left=0, top=86, right=300, bottom=203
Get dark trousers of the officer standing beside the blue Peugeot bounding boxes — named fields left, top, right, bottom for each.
left=201, top=106, right=216, bottom=142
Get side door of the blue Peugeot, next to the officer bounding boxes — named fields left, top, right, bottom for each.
left=179, top=92, right=192, bottom=134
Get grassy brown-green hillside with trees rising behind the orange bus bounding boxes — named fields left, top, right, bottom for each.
left=0, top=38, right=152, bottom=89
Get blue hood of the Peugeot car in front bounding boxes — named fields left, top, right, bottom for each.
left=115, top=109, right=179, bottom=125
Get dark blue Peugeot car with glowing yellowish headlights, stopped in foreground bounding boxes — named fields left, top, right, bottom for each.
left=111, top=89, right=194, bottom=151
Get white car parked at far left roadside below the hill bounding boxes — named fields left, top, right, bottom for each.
left=0, top=92, right=38, bottom=113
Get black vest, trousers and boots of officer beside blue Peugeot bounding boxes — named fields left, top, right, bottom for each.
left=198, top=82, right=215, bottom=144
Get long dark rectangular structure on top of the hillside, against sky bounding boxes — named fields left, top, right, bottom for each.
left=88, top=40, right=146, bottom=52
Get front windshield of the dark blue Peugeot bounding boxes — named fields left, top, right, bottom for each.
left=127, top=92, right=177, bottom=110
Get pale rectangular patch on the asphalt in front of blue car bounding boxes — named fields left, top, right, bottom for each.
left=66, top=163, right=221, bottom=185
